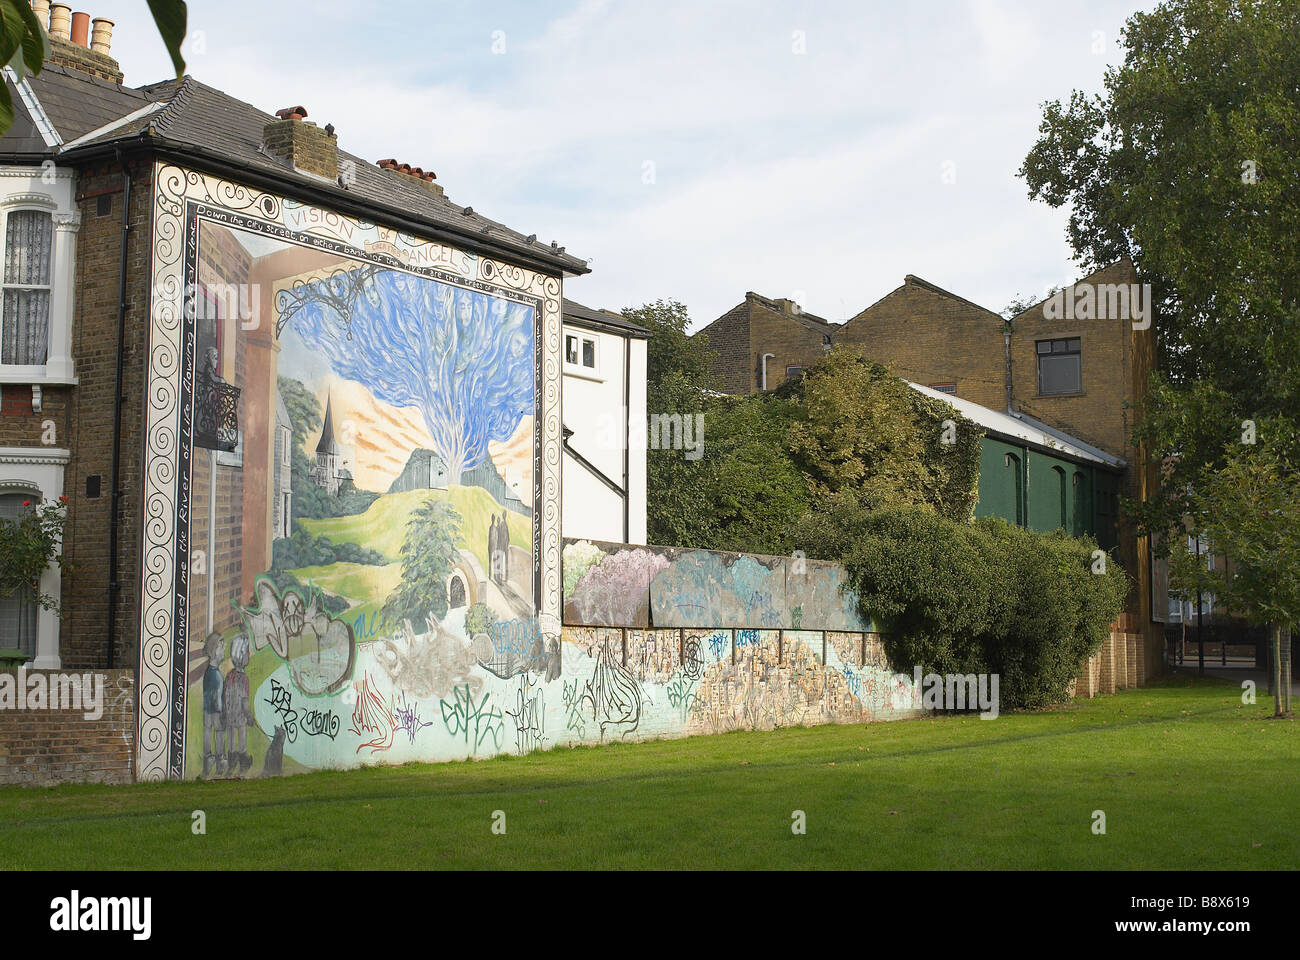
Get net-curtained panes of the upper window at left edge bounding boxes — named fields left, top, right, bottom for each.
left=0, top=209, right=55, bottom=366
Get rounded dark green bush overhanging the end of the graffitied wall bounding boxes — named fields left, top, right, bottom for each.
left=805, top=500, right=1127, bottom=709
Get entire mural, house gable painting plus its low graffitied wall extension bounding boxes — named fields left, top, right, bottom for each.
left=137, top=165, right=914, bottom=779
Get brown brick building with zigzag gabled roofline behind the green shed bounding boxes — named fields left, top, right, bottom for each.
left=701, top=261, right=1169, bottom=676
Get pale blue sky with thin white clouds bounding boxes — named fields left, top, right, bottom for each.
left=89, top=0, right=1153, bottom=329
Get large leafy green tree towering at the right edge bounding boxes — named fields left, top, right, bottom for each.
left=1021, top=0, right=1300, bottom=702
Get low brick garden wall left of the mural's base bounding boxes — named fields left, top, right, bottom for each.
left=0, top=670, right=135, bottom=787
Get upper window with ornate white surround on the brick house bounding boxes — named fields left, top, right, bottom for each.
left=0, top=165, right=81, bottom=385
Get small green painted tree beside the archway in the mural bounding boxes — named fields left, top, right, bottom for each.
left=384, top=498, right=460, bottom=630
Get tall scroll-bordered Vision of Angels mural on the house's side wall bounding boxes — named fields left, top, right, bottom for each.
left=137, top=167, right=562, bottom=779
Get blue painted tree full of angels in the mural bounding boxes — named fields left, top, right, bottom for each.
left=281, top=267, right=534, bottom=484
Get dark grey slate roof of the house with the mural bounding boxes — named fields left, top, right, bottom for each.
left=0, top=64, right=589, bottom=273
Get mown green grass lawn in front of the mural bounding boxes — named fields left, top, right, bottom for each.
left=0, top=679, right=1300, bottom=869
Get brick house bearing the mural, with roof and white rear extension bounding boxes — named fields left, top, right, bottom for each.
left=0, top=7, right=681, bottom=782
